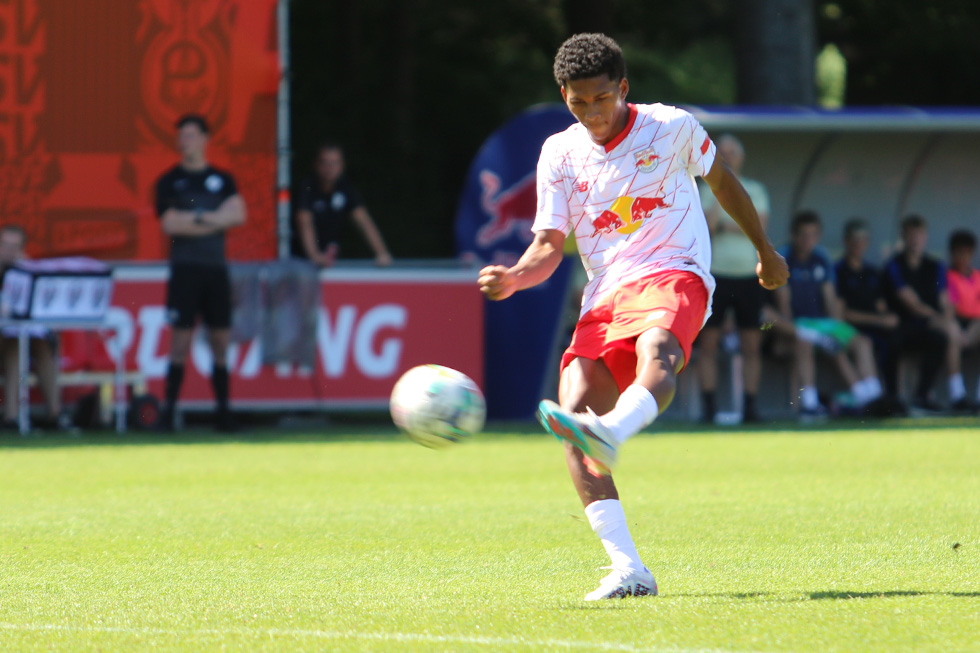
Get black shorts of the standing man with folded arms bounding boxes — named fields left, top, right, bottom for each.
left=167, top=264, right=231, bottom=329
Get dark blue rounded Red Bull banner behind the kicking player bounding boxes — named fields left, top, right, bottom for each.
left=456, top=104, right=580, bottom=418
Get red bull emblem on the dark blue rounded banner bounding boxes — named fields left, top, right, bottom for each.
left=476, top=170, right=538, bottom=247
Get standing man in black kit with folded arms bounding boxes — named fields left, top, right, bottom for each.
left=156, top=114, right=245, bottom=431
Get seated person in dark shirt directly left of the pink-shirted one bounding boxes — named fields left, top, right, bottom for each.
left=882, top=215, right=975, bottom=412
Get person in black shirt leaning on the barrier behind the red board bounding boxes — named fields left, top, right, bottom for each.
left=293, top=142, right=391, bottom=267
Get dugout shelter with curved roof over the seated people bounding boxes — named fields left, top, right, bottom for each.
left=670, top=107, right=980, bottom=418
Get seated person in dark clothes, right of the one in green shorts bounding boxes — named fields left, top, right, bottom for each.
left=834, top=218, right=912, bottom=412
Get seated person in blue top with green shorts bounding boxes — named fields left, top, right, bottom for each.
left=774, top=211, right=882, bottom=419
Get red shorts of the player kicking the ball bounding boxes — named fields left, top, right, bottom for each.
left=561, top=270, right=708, bottom=392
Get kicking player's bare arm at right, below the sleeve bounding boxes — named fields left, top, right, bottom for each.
left=704, top=157, right=789, bottom=290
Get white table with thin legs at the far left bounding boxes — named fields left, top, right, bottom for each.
left=0, top=319, right=126, bottom=435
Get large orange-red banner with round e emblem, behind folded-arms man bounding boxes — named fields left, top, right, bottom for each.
left=0, top=0, right=279, bottom=260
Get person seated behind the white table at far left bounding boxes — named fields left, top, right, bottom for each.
left=0, top=225, right=67, bottom=429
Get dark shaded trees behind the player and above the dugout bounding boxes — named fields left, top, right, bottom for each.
left=291, top=0, right=980, bottom=258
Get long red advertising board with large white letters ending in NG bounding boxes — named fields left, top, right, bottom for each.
left=63, top=266, right=484, bottom=409
